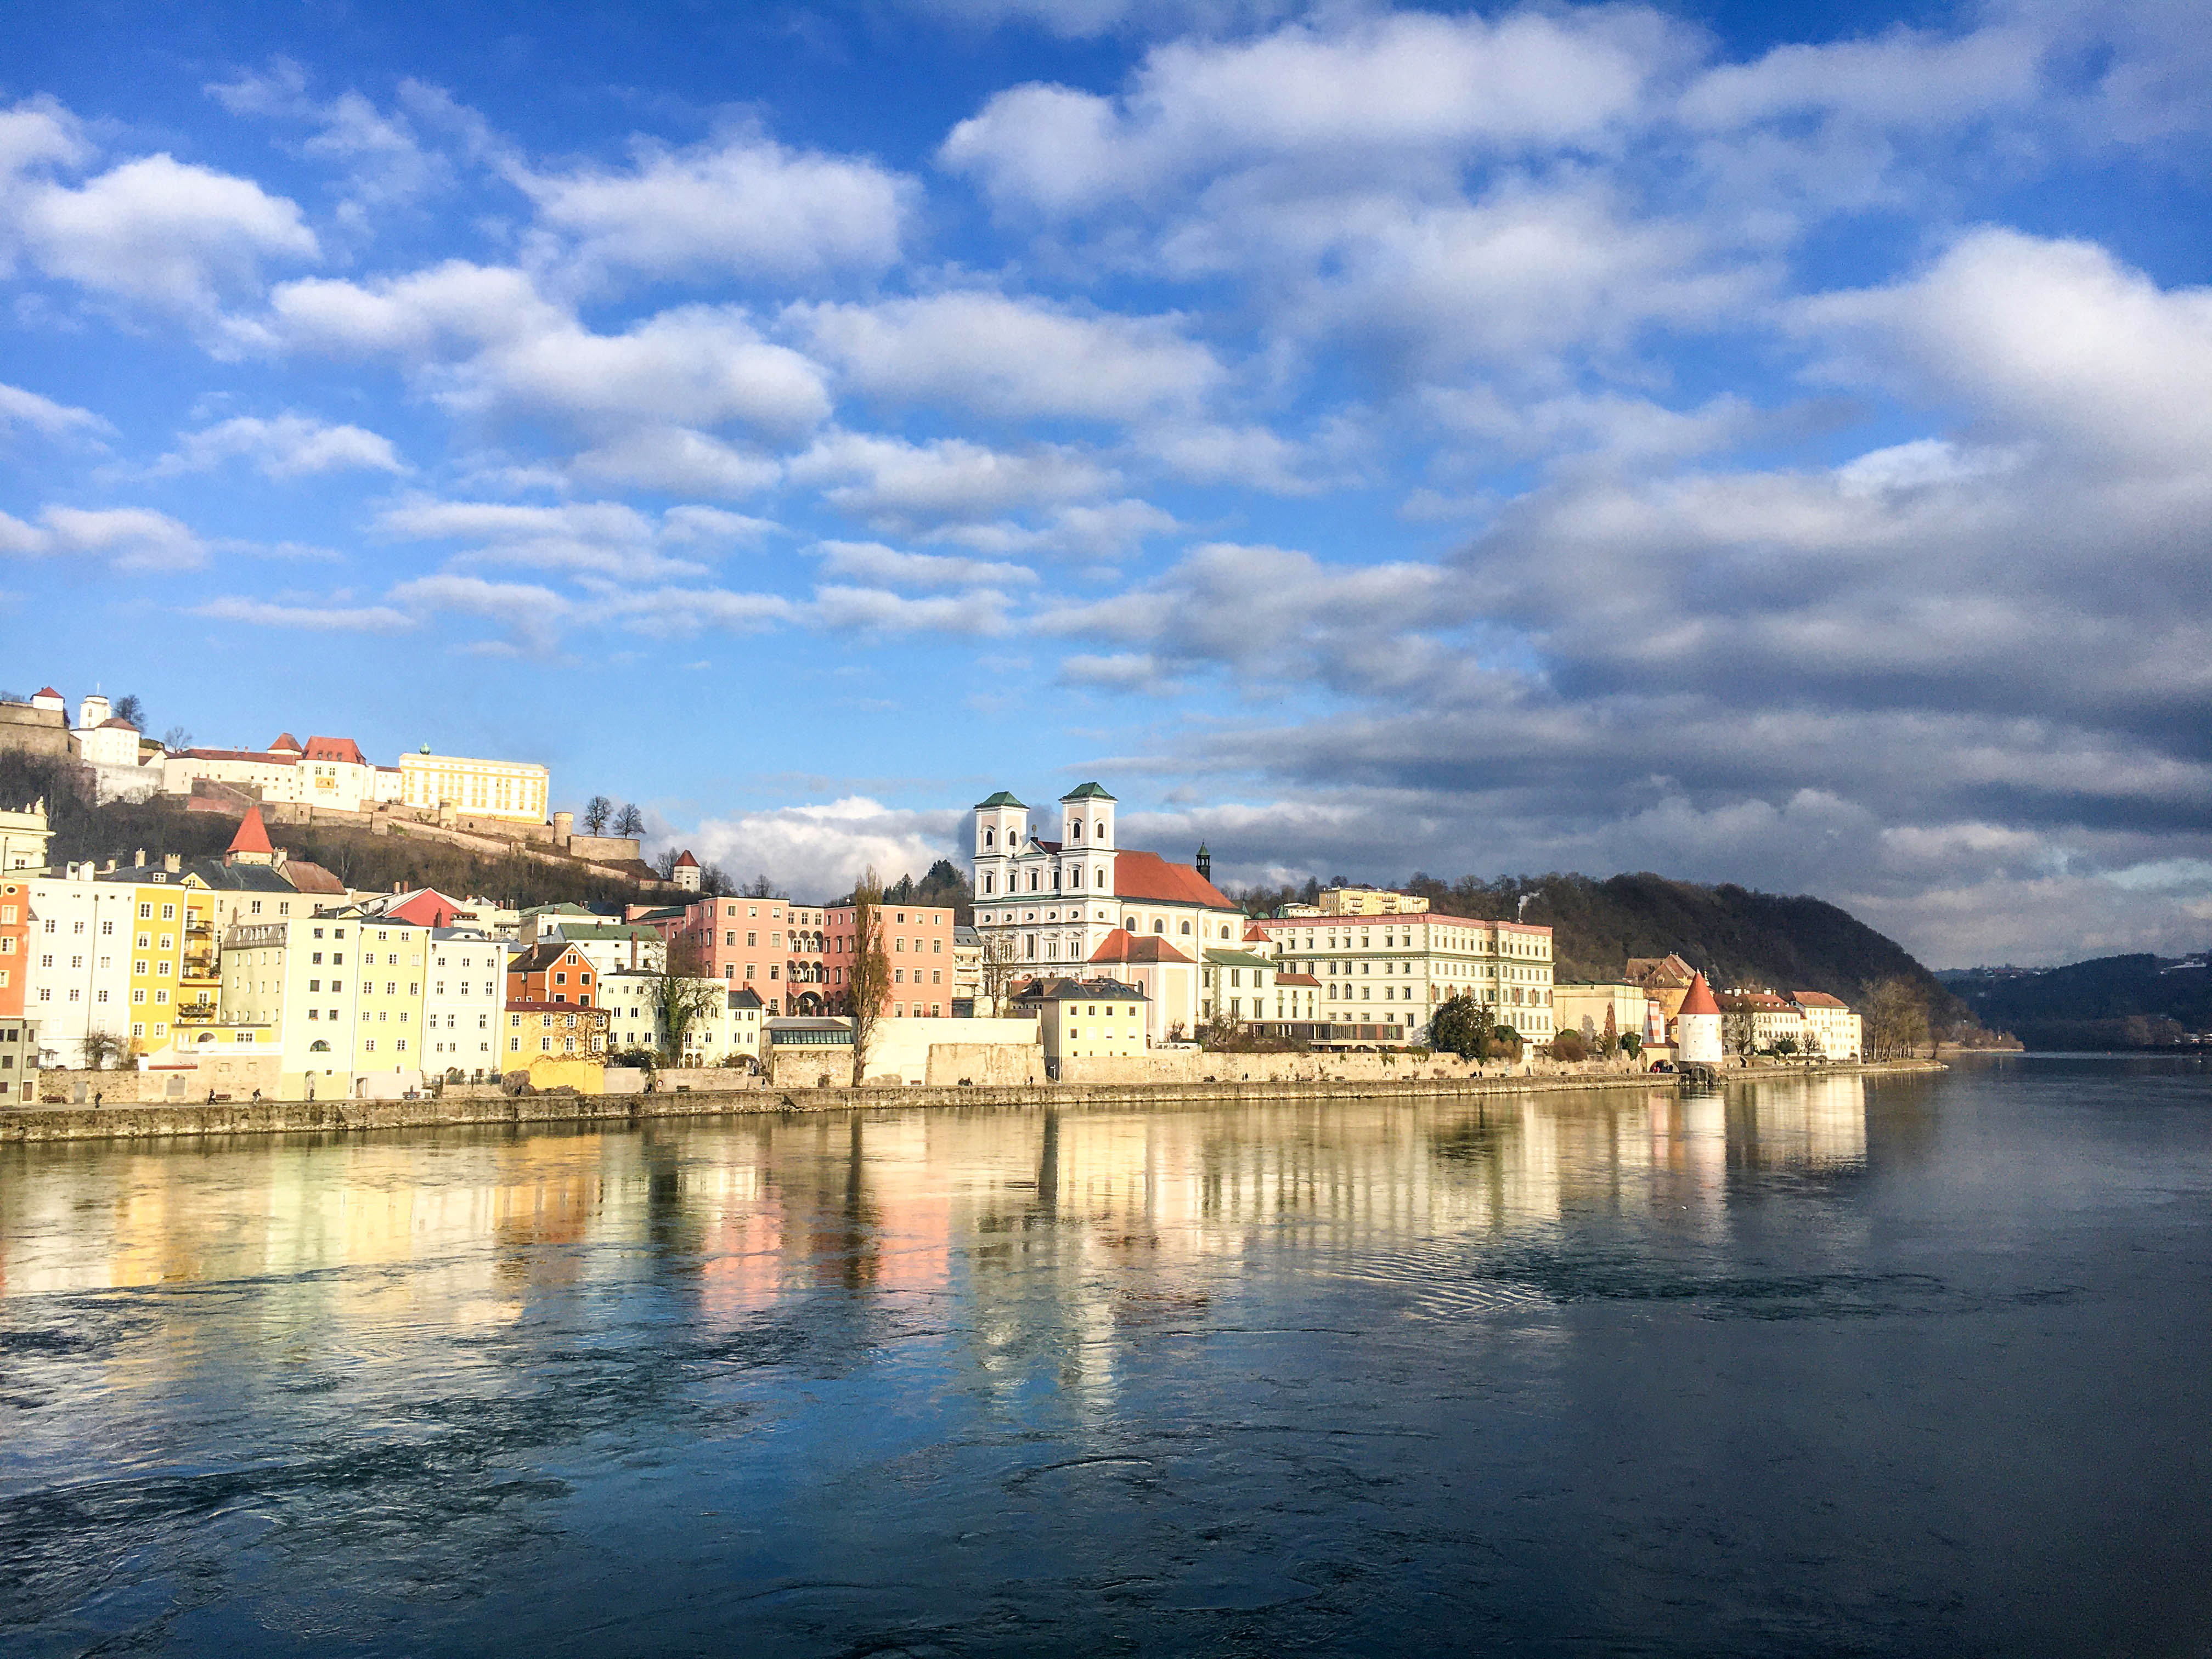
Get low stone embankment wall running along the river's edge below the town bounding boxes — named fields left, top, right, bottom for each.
left=0, top=1059, right=1944, bottom=1144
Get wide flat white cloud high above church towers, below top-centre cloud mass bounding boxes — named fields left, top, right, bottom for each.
left=783, top=290, right=1223, bottom=420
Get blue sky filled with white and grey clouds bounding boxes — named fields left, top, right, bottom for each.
left=0, top=0, right=2212, bottom=967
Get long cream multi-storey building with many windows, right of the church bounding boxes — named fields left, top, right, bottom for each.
left=1248, top=911, right=1558, bottom=1044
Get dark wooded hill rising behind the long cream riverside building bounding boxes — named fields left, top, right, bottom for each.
left=1252, top=872, right=1968, bottom=1024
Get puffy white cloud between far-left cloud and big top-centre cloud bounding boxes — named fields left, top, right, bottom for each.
left=515, top=135, right=911, bottom=279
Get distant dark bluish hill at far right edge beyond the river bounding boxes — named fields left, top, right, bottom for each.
left=1936, top=953, right=2212, bottom=1048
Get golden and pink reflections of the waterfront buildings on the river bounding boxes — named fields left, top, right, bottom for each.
left=0, top=1077, right=1867, bottom=1411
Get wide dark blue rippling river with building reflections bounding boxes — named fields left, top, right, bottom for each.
left=0, top=1057, right=2212, bottom=1659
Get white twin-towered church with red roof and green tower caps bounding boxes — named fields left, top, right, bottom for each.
left=969, top=783, right=1245, bottom=1042
